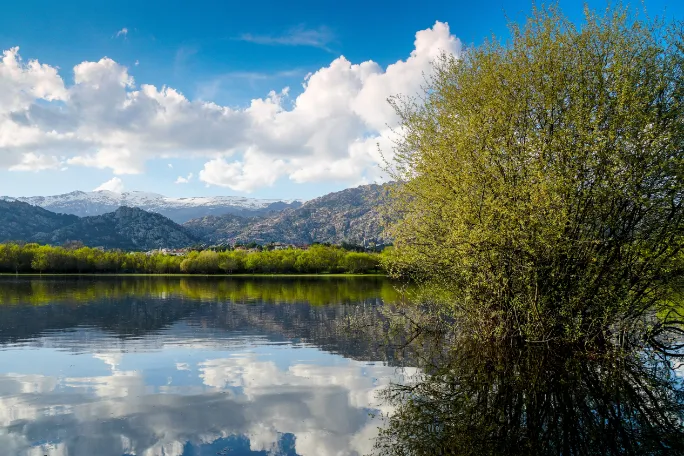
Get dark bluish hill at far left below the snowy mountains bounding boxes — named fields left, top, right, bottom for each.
left=0, top=201, right=197, bottom=250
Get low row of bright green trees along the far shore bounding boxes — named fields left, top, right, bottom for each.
left=0, top=244, right=381, bottom=274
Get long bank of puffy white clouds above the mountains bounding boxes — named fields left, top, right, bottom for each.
left=0, top=22, right=461, bottom=192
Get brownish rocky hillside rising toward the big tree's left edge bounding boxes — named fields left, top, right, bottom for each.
left=184, top=185, right=387, bottom=244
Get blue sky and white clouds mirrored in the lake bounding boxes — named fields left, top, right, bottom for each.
left=0, top=322, right=412, bottom=456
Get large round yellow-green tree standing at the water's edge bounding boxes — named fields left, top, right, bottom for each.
left=391, top=8, right=684, bottom=340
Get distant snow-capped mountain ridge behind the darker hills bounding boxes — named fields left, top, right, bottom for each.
left=0, top=190, right=302, bottom=223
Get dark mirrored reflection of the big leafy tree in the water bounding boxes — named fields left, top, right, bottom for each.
left=368, top=308, right=684, bottom=455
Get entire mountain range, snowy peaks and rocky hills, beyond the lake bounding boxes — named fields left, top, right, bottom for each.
left=0, top=185, right=388, bottom=250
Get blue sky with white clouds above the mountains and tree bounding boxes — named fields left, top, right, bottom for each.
left=0, top=0, right=684, bottom=199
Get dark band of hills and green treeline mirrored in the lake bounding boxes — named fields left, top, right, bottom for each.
left=0, top=278, right=399, bottom=363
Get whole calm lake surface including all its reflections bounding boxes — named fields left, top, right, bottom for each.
left=0, top=276, right=684, bottom=456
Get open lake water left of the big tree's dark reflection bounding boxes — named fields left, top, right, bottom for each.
left=0, top=278, right=401, bottom=456
